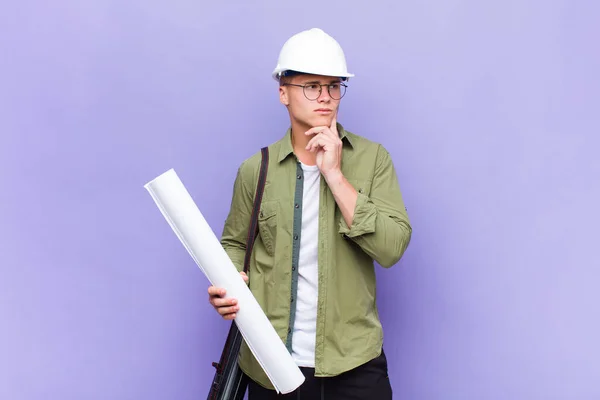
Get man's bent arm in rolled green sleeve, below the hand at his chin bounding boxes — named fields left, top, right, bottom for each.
left=328, top=146, right=412, bottom=268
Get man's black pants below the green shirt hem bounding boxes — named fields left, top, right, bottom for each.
left=248, top=350, right=392, bottom=400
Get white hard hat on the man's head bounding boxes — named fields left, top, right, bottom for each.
left=272, top=28, right=354, bottom=80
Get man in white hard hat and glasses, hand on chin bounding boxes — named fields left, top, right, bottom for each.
left=208, top=29, right=412, bottom=400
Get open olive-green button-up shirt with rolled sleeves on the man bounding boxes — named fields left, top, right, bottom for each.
left=221, top=124, right=412, bottom=388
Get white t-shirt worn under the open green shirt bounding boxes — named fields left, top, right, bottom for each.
left=292, top=164, right=321, bottom=368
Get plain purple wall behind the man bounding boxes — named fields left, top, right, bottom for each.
left=0, top=0, right=600, bottom=400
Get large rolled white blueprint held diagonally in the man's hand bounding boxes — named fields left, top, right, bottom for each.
left=144, top=169, right=304, bottom=394
